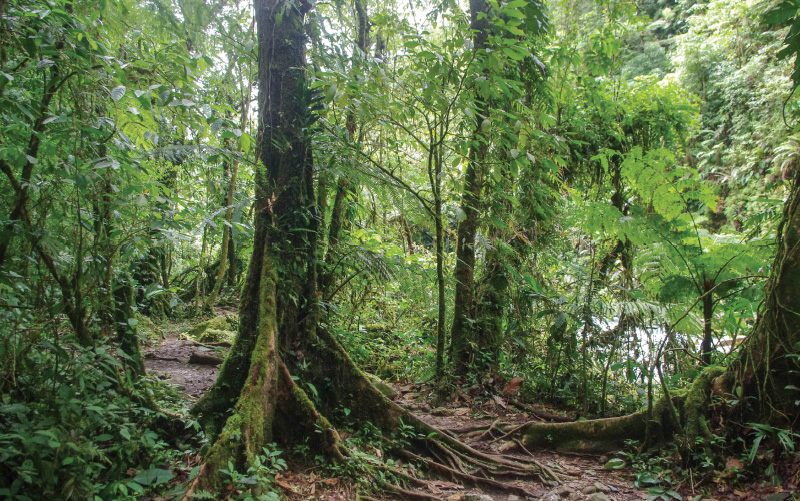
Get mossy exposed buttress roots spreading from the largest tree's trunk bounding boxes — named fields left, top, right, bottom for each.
left=186, top=324, right=557, bottom=499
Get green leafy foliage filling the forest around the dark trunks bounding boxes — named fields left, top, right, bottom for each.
left=0, top=0, right=800, bottom=492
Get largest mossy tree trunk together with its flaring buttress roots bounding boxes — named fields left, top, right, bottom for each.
left=184, top=0, right=551, bottom=492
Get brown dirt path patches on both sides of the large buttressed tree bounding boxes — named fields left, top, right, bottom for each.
left=145, top=333, right=636, bottom=501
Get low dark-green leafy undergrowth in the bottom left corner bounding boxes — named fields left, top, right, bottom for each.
left=0, top=334, right=197, bottom=500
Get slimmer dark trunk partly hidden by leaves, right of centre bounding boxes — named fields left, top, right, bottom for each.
left=450, top=0, right=489, bottom=375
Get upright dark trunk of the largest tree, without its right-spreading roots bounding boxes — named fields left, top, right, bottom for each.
left=193, top=0, right=317, bottom=469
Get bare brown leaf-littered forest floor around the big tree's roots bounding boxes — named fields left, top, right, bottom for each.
left=145, top=326, right=789, bottom=501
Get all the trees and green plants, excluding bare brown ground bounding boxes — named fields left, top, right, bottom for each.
left=0, top=0, right=800, bottom=499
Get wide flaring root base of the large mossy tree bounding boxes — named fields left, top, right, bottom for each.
left=185, top=331, right=558, bottom=499
